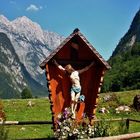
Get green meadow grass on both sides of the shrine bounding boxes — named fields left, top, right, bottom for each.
left=3, top=90, right=140, bottom=139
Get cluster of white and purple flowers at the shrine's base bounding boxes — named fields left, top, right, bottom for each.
left=55, top=108, right=104, bottom=139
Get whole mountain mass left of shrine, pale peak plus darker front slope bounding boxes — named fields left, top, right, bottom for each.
left=0, top=15, right=64, bottom=98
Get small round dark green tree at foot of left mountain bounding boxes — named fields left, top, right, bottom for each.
left=21, top=87, right=32, bottom=99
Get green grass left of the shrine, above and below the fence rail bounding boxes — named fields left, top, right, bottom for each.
left=3, top=98, right=53, bottom=139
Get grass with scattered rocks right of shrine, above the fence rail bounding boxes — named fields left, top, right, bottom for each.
left=96, top=90, right=140, bottom=119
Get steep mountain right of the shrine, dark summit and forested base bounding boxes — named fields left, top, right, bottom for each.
left=102, top=10, right=140, bottom=92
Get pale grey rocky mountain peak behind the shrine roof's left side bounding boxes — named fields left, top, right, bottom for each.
left=0, top=15, right=64, bottom=97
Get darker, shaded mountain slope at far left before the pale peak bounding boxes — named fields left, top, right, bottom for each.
left=0, top=33, right=47, bottom=98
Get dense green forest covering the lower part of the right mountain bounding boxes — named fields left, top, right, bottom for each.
left=102, top=43, right=140, bottom=92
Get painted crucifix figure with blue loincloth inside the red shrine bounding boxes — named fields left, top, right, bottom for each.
left=53, top=42, right=94, bottom=119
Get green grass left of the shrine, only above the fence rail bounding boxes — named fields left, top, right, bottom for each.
left=3, top=98, right=51, bottom=121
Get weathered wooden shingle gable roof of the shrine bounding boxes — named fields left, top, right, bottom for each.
left=40, top=28, right=111, bottom=69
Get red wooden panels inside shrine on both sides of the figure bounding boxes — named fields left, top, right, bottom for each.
left=49, top=62, right=103, bottom=121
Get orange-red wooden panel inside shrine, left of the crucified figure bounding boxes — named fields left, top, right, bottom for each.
left=49, top=66, right=70, bottom=121
